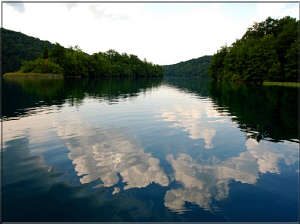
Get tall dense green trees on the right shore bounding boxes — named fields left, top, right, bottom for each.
left=208, top=16, right=299, bottom=82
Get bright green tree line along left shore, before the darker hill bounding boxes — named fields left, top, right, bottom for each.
left=19, top=43, right=164, bottom=77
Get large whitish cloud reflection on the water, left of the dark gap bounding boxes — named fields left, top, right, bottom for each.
left=54, top=116, right=169, bottom=193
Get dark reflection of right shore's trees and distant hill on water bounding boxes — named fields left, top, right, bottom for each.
left=165, top=78, right=299, bottom=142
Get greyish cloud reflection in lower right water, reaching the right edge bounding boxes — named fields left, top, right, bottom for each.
left=164, top=139, right=299, bottom=214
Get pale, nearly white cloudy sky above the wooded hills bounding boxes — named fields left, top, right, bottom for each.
left=2, top=2, right=299, bottom=65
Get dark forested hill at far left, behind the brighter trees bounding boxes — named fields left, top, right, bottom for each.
left=1, top=28, right=54, bottom=75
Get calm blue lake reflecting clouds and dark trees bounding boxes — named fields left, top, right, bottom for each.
left=2, top=78, right=299, bottom=222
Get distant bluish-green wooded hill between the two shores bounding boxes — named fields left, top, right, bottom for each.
left=163, top=56, right=212, bottom=77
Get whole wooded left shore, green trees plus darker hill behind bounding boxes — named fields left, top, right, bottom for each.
left=1, top=29, right=164, bottom=77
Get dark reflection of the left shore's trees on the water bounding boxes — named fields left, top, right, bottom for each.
left=3, top=77, right=163, bottom=118
